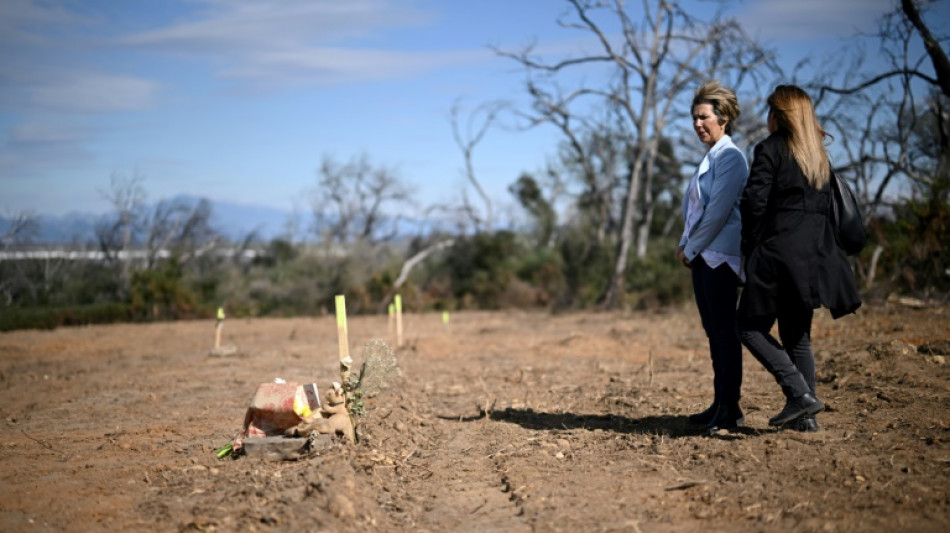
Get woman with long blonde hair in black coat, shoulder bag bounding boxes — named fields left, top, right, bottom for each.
left=738, top=85, right=861, bottom=431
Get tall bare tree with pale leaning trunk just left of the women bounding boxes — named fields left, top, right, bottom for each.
left=498, top=0, right=772, bottom=307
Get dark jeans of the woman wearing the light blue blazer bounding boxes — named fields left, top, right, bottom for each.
left=692, top=256, right=742, bottom=404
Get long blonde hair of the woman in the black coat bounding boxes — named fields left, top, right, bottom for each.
left=768, top=85, right=831, bottom=189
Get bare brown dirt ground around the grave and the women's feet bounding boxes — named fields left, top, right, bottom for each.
left=0, top=302, right=950, bottom=533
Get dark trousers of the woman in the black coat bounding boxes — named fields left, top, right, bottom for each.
left=739, top=299, right=815, bottom=398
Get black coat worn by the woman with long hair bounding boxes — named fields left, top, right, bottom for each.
left=739, top=132, right=861, bottom=318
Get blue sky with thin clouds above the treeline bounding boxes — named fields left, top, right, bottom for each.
left=0, top=0, right=924, bottom=218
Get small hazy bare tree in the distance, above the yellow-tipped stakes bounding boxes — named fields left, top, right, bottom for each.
left=311, top=154, right=409, bottom=244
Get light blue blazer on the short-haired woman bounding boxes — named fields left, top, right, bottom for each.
left=680, top=135, right=749, bottom=261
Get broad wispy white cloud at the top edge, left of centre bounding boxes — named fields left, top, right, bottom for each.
left=119, top=0, right=492, bottom=88
